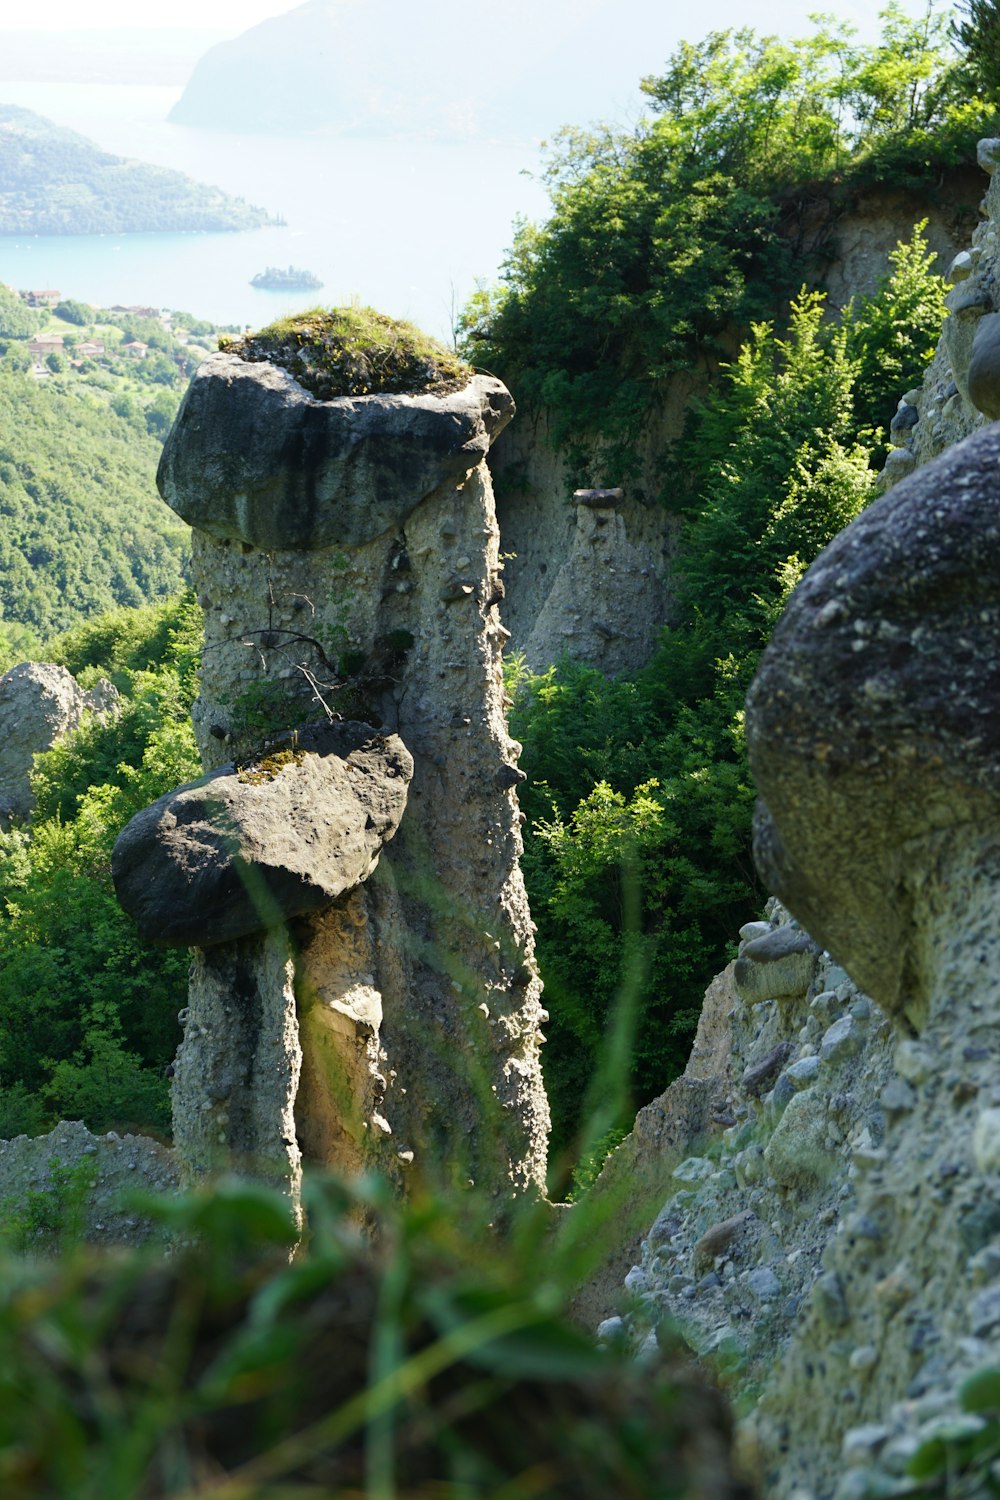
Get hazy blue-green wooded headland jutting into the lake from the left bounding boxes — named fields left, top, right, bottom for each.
left=0, top=104, right=271, bottom=234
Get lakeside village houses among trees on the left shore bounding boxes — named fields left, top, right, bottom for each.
left=4, top=284, right=224, bottom=381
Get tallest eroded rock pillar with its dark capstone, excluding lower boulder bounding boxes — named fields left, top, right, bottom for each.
left=160, top=356, right=549, bottom=1199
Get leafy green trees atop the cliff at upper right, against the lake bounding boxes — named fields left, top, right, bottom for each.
left=459, top=0, right=971, bottom=465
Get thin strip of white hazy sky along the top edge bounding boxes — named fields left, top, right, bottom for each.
left=0, top=0, right=924, bottom=41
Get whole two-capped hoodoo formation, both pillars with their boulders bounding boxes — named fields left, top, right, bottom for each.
left=118, top=340, right=549, bottom=1202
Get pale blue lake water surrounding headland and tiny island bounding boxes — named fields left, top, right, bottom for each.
left=0, top=83, right=547, bottom=338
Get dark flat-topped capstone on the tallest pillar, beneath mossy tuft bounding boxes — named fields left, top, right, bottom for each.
left=156, top=354, right=514, bottom=552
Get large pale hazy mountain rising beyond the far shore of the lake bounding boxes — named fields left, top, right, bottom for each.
left=169, top=0, right=641, bottom=141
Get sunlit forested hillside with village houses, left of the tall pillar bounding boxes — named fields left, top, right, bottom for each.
left=0, top=287, right=227, bottom=666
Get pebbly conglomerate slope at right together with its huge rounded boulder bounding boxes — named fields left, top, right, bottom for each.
left=604, top=414, right=1000, bottom=1500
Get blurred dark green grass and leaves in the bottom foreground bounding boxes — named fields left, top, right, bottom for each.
left=0, top=1179, right=724, bottom=1500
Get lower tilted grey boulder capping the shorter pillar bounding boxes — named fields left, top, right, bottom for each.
left=111, top=723, right=414, bottom=948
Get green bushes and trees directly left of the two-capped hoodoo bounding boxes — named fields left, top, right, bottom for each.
left=0, top=599, right=199, bottom=1133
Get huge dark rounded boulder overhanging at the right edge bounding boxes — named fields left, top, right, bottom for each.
left=747, top=426, right=1000, bottom=1026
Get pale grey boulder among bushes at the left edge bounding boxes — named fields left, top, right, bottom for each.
left=0, top=662, right=118, bottom=828
